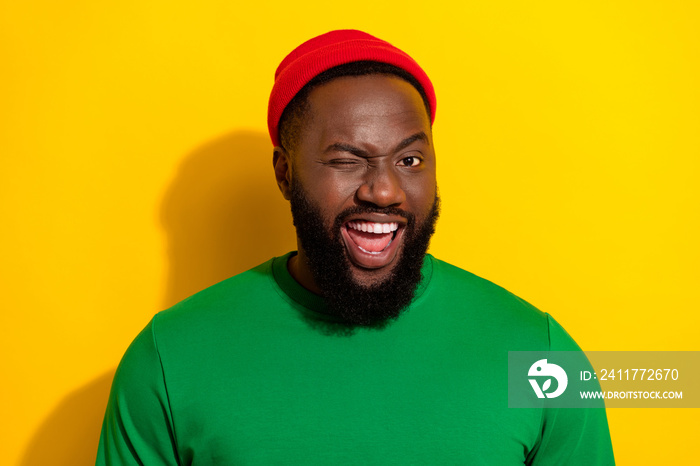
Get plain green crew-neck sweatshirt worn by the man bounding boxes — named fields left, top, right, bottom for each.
left=96, top=253, right=614, bottom=466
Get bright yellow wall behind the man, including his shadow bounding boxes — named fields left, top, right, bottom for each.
left=0, top=0, right=700, bottom=466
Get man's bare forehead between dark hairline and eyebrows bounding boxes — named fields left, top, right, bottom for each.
left=302, top=75, right=430, bottom=149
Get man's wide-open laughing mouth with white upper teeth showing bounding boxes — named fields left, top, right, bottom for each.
left=341, top=220, right=404, bottom=269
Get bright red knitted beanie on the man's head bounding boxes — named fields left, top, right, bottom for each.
left=267, top=29, right=436, bottom=146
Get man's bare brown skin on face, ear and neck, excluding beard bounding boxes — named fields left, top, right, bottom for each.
left=273, top=75, right=437, bottom=294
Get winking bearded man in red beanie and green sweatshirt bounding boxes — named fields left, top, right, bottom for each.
left=97, top=31, right=614, bottom=465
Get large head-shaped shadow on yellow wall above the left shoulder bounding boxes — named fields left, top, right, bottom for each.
left=161, top=131, right=296, bottom=308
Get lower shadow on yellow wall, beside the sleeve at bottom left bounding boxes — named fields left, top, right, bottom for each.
left=20, top=369, right=116, bottom=466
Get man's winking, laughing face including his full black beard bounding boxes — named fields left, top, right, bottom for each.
left=280, top=75, right=437, bottom=323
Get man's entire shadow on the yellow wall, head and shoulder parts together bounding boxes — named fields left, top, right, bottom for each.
left=20, top=131, right=296, bottom=466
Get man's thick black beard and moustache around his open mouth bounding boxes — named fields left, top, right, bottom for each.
left=290, top=183, right=440, bottom=327
